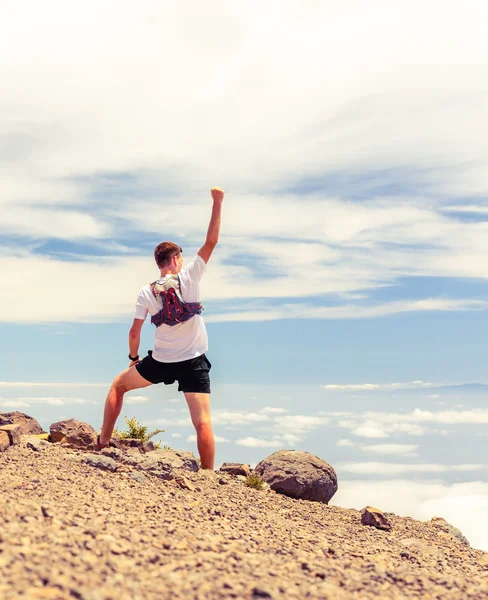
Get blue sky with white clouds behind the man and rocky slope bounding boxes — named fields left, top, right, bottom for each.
left=0, top=0, right=488, bottom=551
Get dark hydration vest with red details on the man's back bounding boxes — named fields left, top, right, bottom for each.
left=150, top=275, right=203, bottom=327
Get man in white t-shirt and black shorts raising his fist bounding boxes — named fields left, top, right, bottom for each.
left=98, top=188, right=224, bottom=469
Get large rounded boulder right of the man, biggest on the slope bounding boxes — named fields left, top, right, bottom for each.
left=254, top=450, right=337, bottom=504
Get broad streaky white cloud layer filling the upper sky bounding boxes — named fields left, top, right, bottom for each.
left=0, top=0, right=488, bottom=322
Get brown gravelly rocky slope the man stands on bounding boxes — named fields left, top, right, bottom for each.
left=0, top=437, right=488, bottom=600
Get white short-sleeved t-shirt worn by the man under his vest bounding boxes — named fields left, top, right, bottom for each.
left=135, top=254, right=208, bottom=362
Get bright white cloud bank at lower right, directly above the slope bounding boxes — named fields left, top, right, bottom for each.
left=330, top=479, right=488, bottom=551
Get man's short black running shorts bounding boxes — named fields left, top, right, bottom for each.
left=136, top=350, right=212, bottom=394
